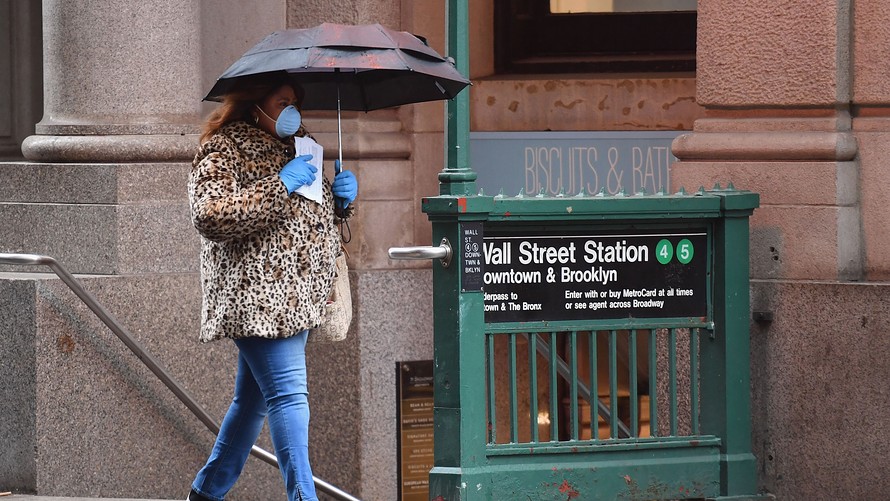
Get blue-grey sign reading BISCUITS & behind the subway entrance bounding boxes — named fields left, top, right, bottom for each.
left=470, top=131, right=684, bottom=196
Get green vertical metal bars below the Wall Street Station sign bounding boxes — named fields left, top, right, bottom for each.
left=485, top=326, right=709, bottom=449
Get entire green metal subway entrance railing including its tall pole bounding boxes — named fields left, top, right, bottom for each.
left=424, top=0, right=759, bottom=501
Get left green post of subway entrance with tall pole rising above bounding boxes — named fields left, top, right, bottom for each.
left=423, top=0, right=492, bottom=501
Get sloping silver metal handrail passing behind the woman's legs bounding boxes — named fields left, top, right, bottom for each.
left=0, top=253, right=361, bottom=501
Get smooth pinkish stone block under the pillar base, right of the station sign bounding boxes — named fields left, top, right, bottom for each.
left=750, top=205, right=862, bottom=280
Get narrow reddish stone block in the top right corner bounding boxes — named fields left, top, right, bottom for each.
left=853, top=0, right=890, bottom=105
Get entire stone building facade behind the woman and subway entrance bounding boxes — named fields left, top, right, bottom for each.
left=0, top=0, right=890, bottom=500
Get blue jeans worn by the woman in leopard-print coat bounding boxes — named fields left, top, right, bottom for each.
left=192, top=331, right=318, bottom=501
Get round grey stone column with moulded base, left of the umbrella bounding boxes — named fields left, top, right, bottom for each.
left=22, top=0, right=201, bottom=162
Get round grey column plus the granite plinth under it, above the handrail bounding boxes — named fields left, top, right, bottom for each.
left=0, top=0, right=202, bottom=275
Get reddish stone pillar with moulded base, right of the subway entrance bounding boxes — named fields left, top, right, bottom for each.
left=671, top=0, right=863, bottom=280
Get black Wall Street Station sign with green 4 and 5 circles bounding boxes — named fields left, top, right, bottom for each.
left=483, top=229, right=708, bottom=323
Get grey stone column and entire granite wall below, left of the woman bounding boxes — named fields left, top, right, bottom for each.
left=0, top=0, right=284, bottom=501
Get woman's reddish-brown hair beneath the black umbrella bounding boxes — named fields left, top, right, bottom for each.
left=201, top=73, right=303, bottom=144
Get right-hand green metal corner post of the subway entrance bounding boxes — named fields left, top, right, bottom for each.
left=700, top=191, right=759, bottom=499
